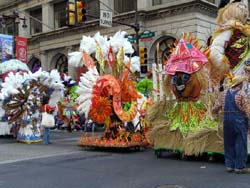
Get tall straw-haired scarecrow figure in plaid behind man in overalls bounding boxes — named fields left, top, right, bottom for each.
left=207, top=0, right=250, bottom=154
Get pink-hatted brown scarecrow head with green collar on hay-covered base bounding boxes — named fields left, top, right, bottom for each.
left=146, top=34, right=223, bottom=157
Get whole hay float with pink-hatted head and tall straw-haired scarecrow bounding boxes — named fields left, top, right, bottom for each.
left=146, top=0, right=250, bottom=159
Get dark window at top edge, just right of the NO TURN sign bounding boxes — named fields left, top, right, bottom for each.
left=114, top=0, right=136, bottom=13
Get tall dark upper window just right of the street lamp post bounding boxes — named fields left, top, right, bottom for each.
left=30, top=8, right=42, bottom=35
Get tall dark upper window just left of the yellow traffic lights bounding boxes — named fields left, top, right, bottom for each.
left=54, top=1, right=66, bottom=28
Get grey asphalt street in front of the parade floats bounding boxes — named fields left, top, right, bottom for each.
left=0, top=131, right=250, bottom=188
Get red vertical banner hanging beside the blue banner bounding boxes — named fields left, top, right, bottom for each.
left=16, top=37, right=27, bottom=63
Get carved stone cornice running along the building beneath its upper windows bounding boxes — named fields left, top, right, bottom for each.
left=28, top=0, right=217, bottom=45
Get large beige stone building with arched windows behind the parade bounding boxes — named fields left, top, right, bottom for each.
left=0, top=0, right=246, bottom=77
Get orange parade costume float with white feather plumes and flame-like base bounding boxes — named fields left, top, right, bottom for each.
left=69, top=31, right=147, bottom=149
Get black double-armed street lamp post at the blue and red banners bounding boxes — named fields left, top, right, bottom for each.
left=0, top=11, right=27, bottom=58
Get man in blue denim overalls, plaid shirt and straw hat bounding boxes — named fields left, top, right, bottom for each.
left=212, top=76, right=250, bottom=174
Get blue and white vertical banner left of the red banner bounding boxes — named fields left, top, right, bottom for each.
left=0, top=34, right=14, bottom=62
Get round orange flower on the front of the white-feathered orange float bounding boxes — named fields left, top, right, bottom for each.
left=89, top=96, right=112, bottom=123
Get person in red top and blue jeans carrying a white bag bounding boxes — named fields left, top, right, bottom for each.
left=41, top=96, right=55, bottom=145
